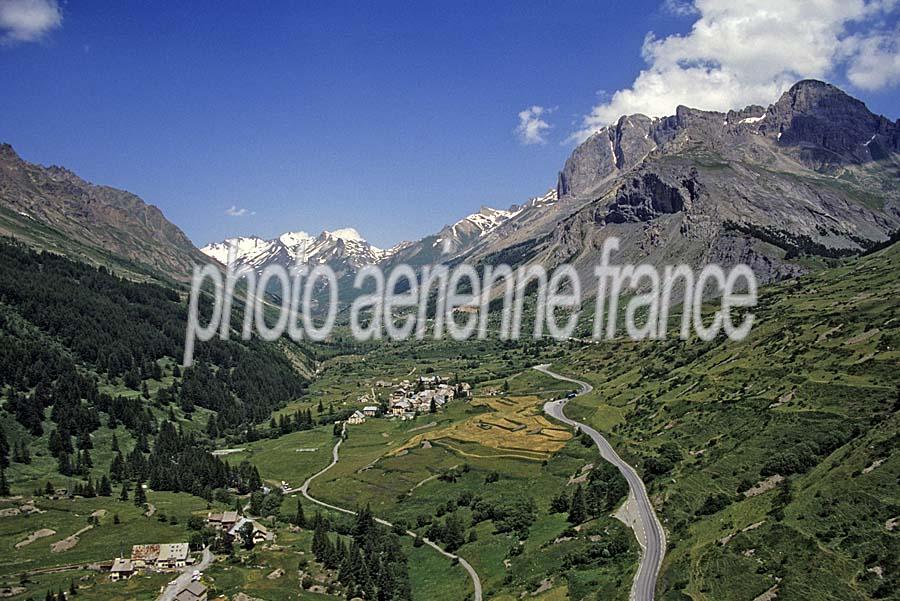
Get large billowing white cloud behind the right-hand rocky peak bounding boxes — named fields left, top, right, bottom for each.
left=572, top=0, right=900, bottom=141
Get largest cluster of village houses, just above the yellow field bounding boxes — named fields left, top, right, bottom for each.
left=347, top=375, right=472, bottom=424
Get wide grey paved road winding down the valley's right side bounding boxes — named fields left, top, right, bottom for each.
left=534, top=364, right=666, bottom=601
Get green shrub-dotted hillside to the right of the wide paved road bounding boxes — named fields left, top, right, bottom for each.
left=566, top=244, right=900, bottom=601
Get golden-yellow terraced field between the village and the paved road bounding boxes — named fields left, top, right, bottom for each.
left=391, top=396, right=572, bottom=461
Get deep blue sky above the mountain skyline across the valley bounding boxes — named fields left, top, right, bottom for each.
left=0, top=0, right=900, bottom=246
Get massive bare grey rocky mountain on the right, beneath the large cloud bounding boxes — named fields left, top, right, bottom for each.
left=484, top=80, right=900, bottom=294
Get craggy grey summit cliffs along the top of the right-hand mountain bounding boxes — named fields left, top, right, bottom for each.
left=557, top=79, right=900, bottom=197
